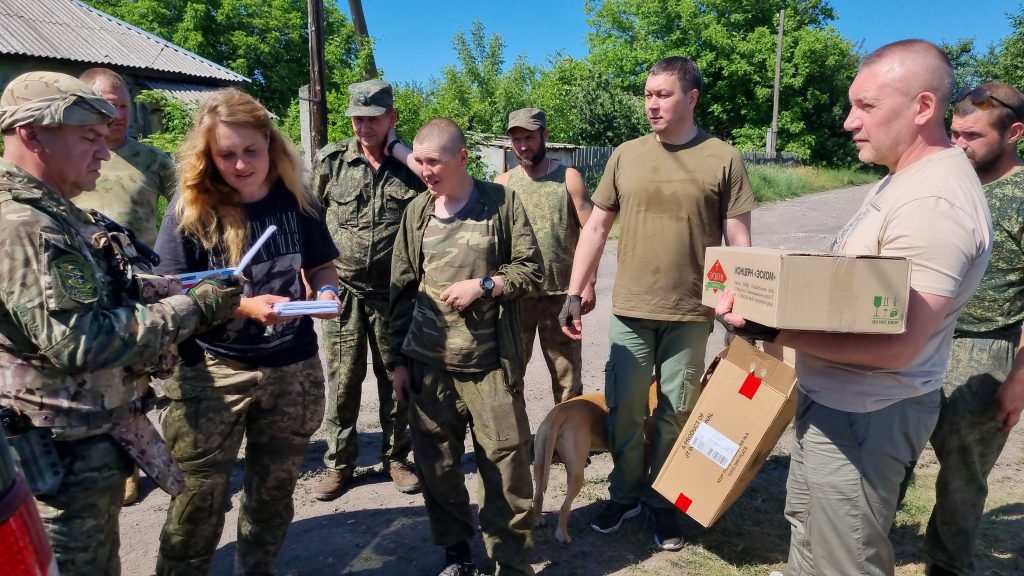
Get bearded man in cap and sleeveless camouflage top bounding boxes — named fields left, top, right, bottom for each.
left=495, top=108, right=595, bottom=404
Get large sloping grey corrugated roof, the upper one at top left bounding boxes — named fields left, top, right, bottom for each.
left=0, top=0, right=249, bottom=84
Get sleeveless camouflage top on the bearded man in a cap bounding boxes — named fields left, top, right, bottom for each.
left=508, top=166, right=580, bottom=295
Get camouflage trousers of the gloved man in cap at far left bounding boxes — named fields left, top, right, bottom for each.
left=36, top=435, right=134, bottom=576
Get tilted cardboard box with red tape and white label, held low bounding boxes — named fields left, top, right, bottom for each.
left=654, top=338, right=797, bottom=527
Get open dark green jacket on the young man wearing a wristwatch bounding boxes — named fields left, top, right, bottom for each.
left=389, top=180, right=544, bottom=390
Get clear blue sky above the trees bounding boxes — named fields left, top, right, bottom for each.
left=348, top=0, right=1024, bottom=82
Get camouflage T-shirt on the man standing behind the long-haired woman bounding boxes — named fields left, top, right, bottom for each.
left=73, top=138, right=177, bottom=248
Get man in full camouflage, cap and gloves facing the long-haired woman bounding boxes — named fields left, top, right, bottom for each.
left=0, top=72, right=240, bottom=576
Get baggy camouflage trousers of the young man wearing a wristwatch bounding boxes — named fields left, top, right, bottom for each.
left=409, top=361, right=534, bottom=576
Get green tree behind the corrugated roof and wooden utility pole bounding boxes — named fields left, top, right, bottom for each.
left=84, top=0, right=369, bottom=116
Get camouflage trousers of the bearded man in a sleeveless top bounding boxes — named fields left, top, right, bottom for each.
left=519, top=294, right=583, bottom=404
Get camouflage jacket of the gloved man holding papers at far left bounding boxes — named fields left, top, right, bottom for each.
left=0, top=160, right=199, bottom=440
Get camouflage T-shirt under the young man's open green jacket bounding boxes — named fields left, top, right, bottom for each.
left=401, top=190, right=500, bottom=372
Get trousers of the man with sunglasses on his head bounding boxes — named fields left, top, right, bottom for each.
left=925, top=331, right=1020, bottom=574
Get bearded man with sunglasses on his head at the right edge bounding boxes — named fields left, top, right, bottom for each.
left=925, top=83, right=1024, bottom=576
